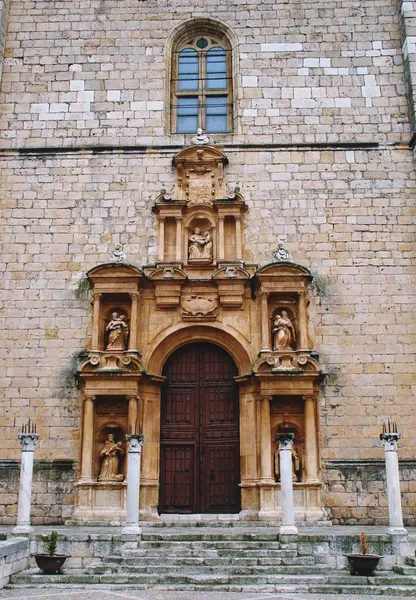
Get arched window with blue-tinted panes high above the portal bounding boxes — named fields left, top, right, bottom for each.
left=171, top=32, right=232, bottom=133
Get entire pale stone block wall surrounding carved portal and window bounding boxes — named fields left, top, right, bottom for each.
left=0, top=0, right=416, bottom=524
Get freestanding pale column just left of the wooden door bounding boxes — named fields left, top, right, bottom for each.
left=121, top=434, right=144, bottom=534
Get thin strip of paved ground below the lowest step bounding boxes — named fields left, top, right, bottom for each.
left=0, top=588, right=416, bottom=600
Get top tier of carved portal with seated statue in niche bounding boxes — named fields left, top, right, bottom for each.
left=153, top=146, right=247, bottom=278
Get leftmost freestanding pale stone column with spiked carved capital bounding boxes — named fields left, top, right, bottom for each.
left=13, top=421, right=39, bottom=533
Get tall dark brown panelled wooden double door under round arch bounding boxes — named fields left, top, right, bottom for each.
left=159, top=342, right=241, bottom=513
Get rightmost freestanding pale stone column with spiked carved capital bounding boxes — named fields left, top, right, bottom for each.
left=380, top=428, right=407, bottom=534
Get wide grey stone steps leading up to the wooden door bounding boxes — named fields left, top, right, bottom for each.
left=9, top=527, right=416, bottom=598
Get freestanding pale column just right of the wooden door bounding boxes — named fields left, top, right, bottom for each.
left=276, top=433, right=298, bottom=535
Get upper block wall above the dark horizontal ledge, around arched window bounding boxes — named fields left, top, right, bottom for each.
left=0, top=0, right=410, bottom=147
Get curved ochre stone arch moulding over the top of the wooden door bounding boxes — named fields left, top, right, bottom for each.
left=147, top=324, right=252, bottom=376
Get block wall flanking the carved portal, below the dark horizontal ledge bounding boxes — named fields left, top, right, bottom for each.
left=0, top=147, right=416, bottom=515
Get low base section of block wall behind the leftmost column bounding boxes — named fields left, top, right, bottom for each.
left=0, top=460, right=75, bottom=525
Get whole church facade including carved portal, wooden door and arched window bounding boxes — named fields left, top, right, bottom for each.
left=0, top=0, right=416, bottom=525
